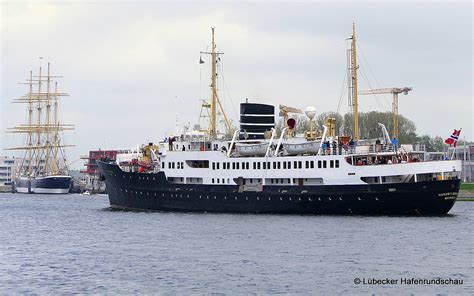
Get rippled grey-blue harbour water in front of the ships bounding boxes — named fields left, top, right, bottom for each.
left=0, top=194, right=474, bottom=295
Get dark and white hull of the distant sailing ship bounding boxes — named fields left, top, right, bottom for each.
left=15, top=176, right=72, bottom=194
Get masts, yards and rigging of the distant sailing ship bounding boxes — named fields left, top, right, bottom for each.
left=7, top=63, right=74, bottom=178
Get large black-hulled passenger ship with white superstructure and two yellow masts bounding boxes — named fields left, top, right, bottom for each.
left=98, top=28, right=461, bottom=215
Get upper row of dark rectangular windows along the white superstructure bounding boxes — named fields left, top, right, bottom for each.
left=162, top=159, right=339, bottom=170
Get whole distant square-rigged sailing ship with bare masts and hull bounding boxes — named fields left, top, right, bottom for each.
left=7, top=63, right=74, bottom=194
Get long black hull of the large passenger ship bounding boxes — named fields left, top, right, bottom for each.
left=98, top=162, right=460, bottom=215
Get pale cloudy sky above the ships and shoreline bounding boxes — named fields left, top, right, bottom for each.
left=0, top=1, right=474, bottom=168
